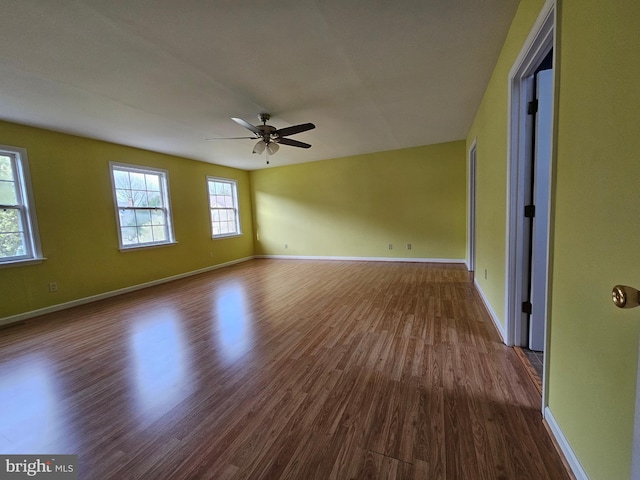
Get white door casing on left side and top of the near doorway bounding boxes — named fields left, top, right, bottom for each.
left=505, top=0, right=556, bottom=346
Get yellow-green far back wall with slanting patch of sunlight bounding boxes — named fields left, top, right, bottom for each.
left=251, top=141, right=466, bottom=259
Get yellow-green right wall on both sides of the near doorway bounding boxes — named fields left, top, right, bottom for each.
left=467, top=0, right=640, bottom=480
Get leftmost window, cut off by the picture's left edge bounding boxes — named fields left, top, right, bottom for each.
left=0, top=145, right=42, bottom=265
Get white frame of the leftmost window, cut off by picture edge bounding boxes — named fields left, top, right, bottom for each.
left=0, top=145, right=45, bottom=268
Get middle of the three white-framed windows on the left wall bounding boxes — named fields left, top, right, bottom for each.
left=110, top=162, right=175, bottom=249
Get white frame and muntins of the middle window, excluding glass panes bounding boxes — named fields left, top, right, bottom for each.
left=109, top=162, right=177, bottom=251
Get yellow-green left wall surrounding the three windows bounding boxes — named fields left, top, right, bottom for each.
left=0, top=122, right=253, bottom=319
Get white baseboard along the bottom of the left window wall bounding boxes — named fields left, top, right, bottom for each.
left=0, top=256, right=255, bottom=326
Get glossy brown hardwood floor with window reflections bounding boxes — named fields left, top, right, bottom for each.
left=0, top=260, right=569, bottom=480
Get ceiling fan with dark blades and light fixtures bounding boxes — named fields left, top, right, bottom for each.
left=207, top=113, right=316, bottom=163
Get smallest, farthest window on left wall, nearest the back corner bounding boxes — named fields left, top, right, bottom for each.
left=207, top=177, right=242, bottom=238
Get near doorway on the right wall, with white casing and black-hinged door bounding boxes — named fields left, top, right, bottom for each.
left=505, top=2, right=555, bottom=410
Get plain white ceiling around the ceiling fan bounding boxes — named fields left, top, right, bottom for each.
left=0, top=0, right=518, bottom=170
